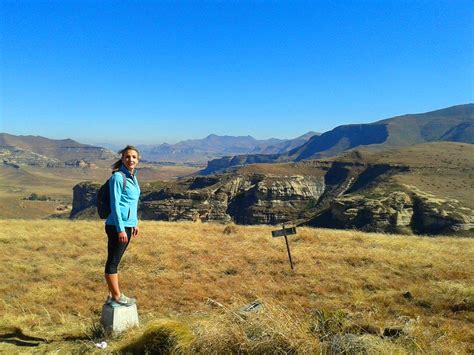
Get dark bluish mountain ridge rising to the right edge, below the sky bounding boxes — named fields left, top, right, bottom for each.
left=202, top=104, right=474, bottom=174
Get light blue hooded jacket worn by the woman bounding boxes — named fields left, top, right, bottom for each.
left=105, top=165, right=140, bottom=232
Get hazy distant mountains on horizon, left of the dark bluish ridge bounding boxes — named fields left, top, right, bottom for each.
left=0, top=132, right=318, bottom=166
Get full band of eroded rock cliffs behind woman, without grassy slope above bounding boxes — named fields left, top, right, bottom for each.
left=71, top=162, right=474, bottom=234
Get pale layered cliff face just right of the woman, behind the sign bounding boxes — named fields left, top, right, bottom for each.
left=140, top=175, right=324, bottom=224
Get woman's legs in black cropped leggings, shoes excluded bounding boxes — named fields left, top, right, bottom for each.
left=105, top=225, right=132, bottom=299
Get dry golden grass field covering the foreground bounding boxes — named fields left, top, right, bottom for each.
left=0, top=220, right=474, bottom=353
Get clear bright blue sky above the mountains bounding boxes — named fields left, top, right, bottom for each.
left=0, top=0, right=474, bottom=144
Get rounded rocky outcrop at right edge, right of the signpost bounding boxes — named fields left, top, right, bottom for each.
left=310, top=191, right=474, bottom=234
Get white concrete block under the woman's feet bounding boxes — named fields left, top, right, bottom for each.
left=100, top=304, right=138, bottom=335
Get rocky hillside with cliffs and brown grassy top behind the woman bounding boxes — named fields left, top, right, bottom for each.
left=71, top=142, right=474, bottom=236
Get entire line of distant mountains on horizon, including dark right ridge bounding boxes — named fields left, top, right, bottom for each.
left=0, top=104, right=474, bottom=175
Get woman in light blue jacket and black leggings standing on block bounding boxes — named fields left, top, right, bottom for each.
left=105, top=145, right=140, bottom=306
